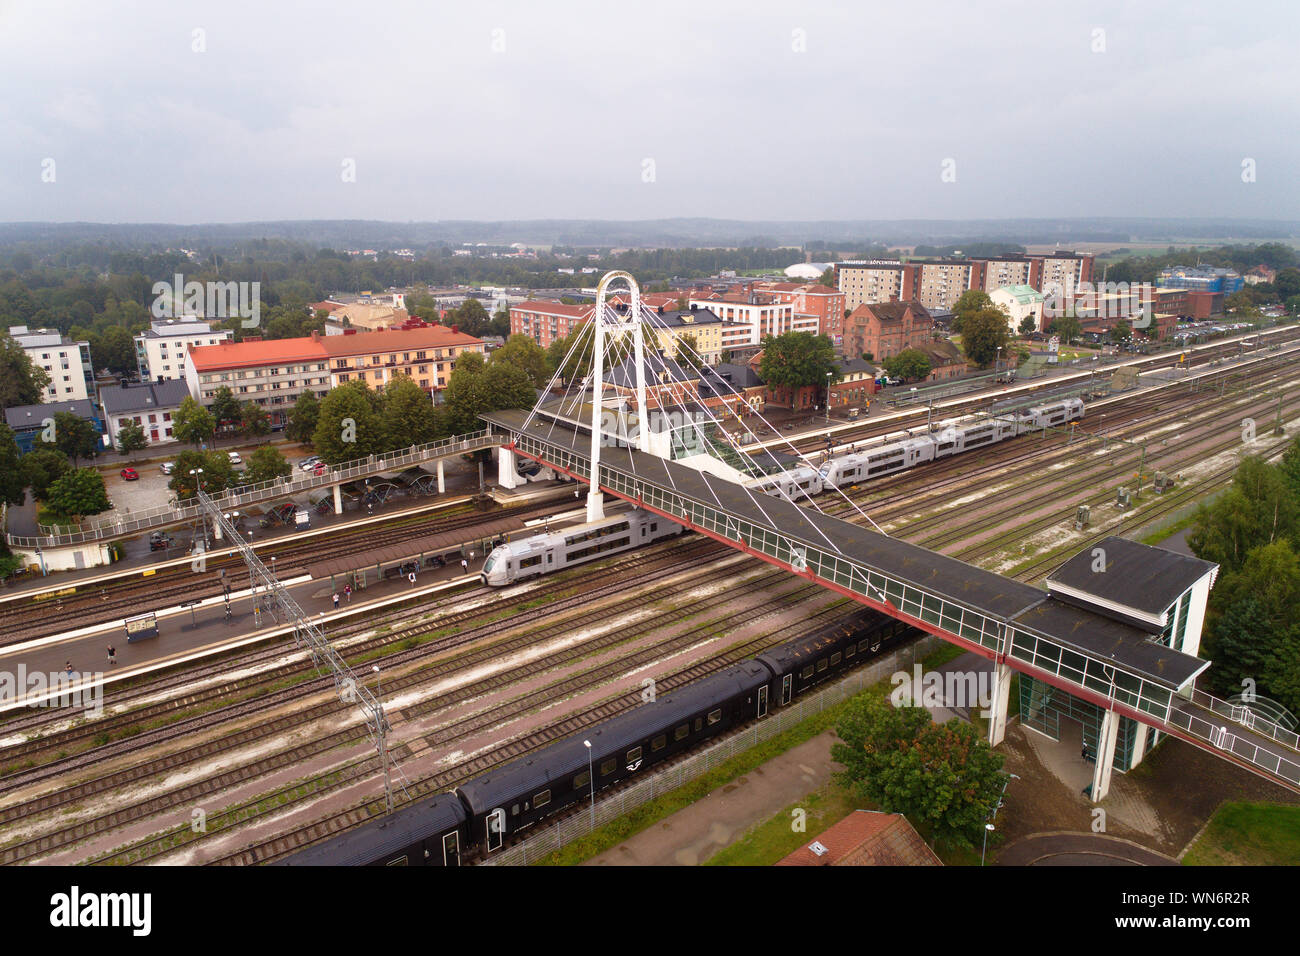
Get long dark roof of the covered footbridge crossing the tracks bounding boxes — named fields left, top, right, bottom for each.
left=480, top=410, right=1209, bottom=691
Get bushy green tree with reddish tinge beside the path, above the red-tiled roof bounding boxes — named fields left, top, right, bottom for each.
left=831, top=693, right=1004, bottom=847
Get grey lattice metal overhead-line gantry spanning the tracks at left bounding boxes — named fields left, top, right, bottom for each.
left=198, top=490, right=411, bottom=813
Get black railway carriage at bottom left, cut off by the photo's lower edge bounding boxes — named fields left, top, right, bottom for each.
left=280, top=793, right=469, bottom=866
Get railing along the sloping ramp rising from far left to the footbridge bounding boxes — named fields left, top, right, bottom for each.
left=7, top=429, right=501, bottom=548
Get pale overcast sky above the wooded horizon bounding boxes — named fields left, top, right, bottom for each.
left=0, top=0, right=1300, bottom=222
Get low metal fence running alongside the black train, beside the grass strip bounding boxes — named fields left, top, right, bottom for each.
left=486, top=636, right=944, bottom=866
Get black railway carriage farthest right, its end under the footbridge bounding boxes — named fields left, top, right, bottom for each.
left=754, top=607, right=922, bottom=708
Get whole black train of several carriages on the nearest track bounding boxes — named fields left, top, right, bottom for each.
left=280, top=607, right=922, bottom=866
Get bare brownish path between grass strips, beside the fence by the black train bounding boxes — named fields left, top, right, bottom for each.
left=585, top=730, right=839, bottom=866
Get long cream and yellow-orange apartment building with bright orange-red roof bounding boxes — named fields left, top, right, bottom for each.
left=186, top=325, right=484, bottom=425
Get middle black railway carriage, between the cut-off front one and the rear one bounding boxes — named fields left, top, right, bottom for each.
left=456, top=661, right=771, bottom=855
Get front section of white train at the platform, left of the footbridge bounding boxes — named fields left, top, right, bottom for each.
left=480, top=509, right=685, bottom=588
